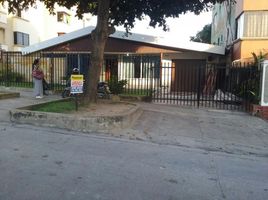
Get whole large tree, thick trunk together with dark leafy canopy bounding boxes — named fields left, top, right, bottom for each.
left=0, top=0, right=231, bottom=103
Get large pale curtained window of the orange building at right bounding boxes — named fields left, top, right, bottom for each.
left=236, top=11, right=268, bottom=38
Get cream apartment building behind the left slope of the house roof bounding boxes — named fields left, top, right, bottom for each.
left=0, top=2, right=91, bottom=51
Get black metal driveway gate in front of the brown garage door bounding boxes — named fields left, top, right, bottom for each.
left=152, top=60, right=260, bottom=110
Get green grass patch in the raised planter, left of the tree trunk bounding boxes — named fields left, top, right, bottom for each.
left=32, top=100, right=75, bottom=113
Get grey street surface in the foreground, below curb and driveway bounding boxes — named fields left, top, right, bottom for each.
left=0, top=122, right=268, bottom=200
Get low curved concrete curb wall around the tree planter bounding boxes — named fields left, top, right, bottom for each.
left=9, top=103, right=143, bottom=133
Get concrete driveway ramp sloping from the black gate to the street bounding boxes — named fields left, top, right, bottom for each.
left=112, top=103, right=268, bottom=157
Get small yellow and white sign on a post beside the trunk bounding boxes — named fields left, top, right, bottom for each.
left=71, top=74, right=84, bottom=111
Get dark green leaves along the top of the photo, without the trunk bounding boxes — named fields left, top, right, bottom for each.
left=0, top=0, right=229, bottom=31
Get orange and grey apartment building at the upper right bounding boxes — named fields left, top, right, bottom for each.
left=211, top=0, right=268, bottom=61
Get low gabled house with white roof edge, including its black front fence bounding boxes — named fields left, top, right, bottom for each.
left=0, top=27, right=255, bottom=110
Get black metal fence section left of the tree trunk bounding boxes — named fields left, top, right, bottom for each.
left=0, top=52, right=90, bottom=91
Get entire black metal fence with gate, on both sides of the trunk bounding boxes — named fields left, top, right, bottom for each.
left=0, top=52, right=260, bottom=110
